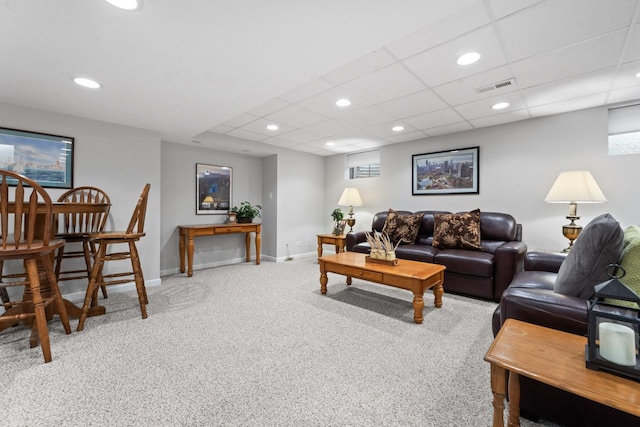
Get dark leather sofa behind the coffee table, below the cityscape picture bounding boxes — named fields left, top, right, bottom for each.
left=346, top=211, right=527, bottom=301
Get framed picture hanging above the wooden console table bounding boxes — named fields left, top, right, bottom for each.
left=196, top=163, right=233, bottom=215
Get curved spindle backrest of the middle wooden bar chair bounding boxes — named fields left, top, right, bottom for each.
left=56, top=186, right=111, bottom=234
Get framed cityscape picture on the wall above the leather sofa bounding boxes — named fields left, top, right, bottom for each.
left=412, top=147, right=480, bottom=195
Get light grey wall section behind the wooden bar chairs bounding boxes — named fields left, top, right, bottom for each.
left=0, top=103, right=160, bottom=295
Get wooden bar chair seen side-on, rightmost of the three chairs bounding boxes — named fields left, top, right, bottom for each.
left=78, top=184, right=151, bottom=331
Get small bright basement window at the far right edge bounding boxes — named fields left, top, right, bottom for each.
left=609, top=104, right=640, bottom=156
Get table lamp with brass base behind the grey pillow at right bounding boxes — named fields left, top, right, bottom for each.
left=544, top=171, right=607, bottom=252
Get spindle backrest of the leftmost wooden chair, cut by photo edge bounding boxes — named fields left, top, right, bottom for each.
left=0, top=169, right=52, bottom=251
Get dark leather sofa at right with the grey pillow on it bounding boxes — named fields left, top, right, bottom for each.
left=492, top=251, right=640, bottom=427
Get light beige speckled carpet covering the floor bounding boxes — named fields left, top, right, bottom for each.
left=0, top=259, right=556, bottom=426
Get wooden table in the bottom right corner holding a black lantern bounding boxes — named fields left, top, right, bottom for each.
left=484, top=319, right=640, bottom=427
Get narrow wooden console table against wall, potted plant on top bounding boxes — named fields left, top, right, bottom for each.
left=178, top=223, right=262, bottom=277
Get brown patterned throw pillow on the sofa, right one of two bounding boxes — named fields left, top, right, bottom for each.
left=433, top=209, right=482, bottom=251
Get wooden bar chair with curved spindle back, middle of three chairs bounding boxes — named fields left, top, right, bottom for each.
left=54, top=186, right=111, bottom=298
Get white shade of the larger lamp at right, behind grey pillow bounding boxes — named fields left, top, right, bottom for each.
left=544, top=171, right=607, bottom=203
